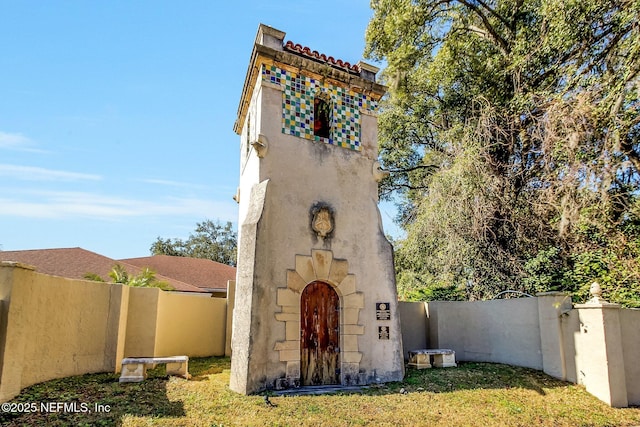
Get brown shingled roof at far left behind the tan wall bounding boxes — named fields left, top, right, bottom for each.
left=0, top=248, right=206, bottom=292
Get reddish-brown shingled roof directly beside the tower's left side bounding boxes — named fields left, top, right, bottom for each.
left=120, top=255, right=236, bottom=292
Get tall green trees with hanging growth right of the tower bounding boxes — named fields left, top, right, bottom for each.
left=366, top=0, right=640, bottom=306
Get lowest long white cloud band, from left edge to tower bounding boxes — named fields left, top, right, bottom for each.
left=0, top=191, right=237, bottom=221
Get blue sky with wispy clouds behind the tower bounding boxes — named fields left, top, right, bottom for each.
left=0, top=0, right=400, bottom=259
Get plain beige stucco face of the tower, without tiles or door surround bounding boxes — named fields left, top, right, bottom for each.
left=231, top=77, right=403, bottom=393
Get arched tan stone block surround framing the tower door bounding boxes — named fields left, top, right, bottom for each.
left=274, top=249, right=364, bottom=385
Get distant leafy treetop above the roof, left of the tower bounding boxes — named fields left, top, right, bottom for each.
left=150, top=220, right=238, bottom=266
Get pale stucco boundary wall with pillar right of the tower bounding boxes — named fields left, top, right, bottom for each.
left=399, top=292, right=640, bottom=407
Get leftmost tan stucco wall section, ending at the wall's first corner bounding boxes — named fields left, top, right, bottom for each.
left=0, top=266, right=117, bottom=399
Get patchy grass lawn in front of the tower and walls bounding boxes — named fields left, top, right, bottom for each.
left=0, top=357, right=640, bottom=426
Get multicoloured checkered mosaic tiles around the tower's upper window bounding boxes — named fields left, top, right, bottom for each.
left=262, top=65, right=378, bottom=151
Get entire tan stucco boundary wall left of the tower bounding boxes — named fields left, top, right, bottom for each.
left=0, top=262, right=229, bottom=402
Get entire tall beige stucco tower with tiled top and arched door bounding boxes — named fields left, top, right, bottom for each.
left=230, top=25, right=404, bottom=394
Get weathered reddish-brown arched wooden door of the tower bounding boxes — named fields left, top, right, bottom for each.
left=300, top=282, right=340, bottom=385
